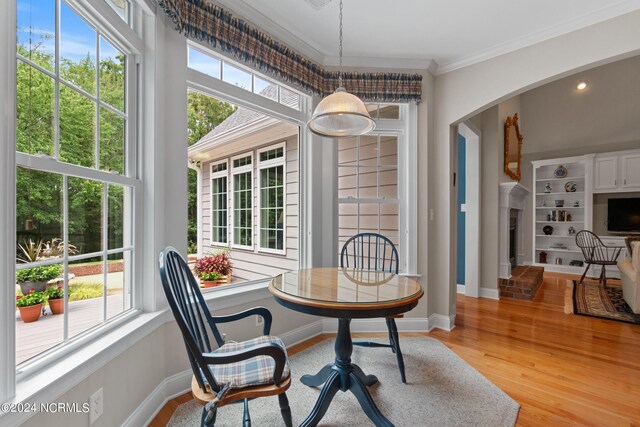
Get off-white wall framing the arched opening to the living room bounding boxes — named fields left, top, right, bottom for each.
left=428, top=12, right=640, bottom=316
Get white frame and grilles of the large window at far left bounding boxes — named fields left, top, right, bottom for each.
left=9, top=0, right=144, bottom=382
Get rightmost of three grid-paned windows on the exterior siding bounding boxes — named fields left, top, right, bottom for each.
left=258, top=145, right=285, bottom=252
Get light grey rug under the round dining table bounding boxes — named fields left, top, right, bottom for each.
left=168, top=337, right=520, bottom=427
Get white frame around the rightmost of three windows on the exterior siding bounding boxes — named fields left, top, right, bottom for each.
left=256, top=141, right=287, bottom=255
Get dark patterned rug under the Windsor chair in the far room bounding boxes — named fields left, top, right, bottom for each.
left=573, top=280, right=640, bottom=324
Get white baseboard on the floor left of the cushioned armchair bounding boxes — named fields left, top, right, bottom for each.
left=122, top=369, right=193, bottom=427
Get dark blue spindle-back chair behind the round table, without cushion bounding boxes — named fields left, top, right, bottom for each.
left=340, top=233, right=407, bottom=383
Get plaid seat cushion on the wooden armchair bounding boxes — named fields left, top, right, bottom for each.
left=209, top=335, right=290, bottom=389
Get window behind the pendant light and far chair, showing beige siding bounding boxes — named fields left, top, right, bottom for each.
left=337, top=104, right=416, bottom=272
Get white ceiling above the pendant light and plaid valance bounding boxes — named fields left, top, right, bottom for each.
left=217, top=0, right=640, bottom=74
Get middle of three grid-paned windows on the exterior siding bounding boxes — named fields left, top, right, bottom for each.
left=232, top=155, right=253, bottom=249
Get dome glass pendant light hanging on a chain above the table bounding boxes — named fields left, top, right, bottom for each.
left=307, top=0, right=376, bottom=137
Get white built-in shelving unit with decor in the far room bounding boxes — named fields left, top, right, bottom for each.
left=531, top=156, right=593, bottom=274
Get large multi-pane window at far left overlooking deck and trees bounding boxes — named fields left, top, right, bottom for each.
left=16, top=0, right=141, bottom=364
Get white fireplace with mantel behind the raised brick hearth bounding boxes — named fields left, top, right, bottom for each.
left=498, top=182, right=530, bottom=279
